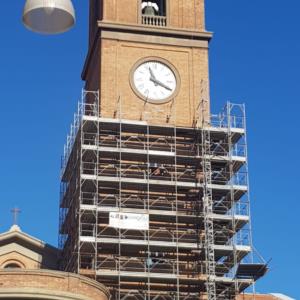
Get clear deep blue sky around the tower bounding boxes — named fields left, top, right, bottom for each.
left=0, top=0, right=300, bottom=298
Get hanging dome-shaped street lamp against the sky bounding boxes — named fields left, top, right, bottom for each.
left=23, top=0, right=75, bottom=34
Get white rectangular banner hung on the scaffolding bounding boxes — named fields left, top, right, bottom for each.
left=109, top=212, right=149, bottom=230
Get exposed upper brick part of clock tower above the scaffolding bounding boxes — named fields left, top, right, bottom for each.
left=82, top=0, right=212, bottom=127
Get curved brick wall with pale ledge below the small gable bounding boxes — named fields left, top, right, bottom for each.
left=0, top=269, right=110, bottom=300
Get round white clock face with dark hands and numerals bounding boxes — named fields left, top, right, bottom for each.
left=133, top=60, right=177, bottom=103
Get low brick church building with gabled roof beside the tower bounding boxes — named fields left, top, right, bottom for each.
left=0, top=225, right=110, bottom=300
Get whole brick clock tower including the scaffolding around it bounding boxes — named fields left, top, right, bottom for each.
left=60, top=0, right=266, bottom=300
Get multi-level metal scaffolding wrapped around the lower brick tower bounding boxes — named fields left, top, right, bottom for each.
left=59, top=91, right=264, bottom=300
